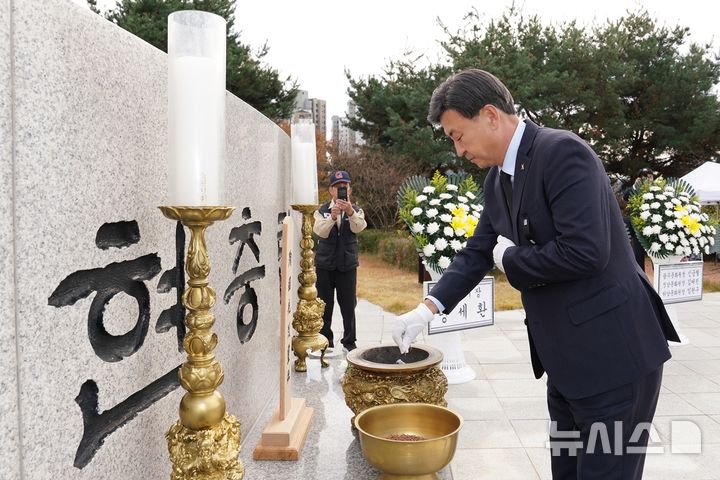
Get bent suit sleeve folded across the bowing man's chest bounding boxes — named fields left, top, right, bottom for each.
left=503, top=138, right=615, bottom=291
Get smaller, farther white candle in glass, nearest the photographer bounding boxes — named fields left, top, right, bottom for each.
left=290, top=122, right=318, bottom=205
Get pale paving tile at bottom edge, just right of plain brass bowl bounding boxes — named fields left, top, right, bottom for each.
left=451, top=448, right=540, bottom=480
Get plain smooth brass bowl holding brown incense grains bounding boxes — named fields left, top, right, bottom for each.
left=355, top=403, right=463, bottom=480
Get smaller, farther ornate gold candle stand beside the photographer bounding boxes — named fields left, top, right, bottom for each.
left=292, top=205, right=330, bottom=372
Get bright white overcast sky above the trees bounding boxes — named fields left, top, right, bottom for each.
left=73, top=0, right=720, bottom=138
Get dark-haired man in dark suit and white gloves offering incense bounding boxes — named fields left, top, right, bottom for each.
left=393, top=69, right=678, bottom=480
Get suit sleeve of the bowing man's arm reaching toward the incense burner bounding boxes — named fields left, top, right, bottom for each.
left=429, top=201, right=497, bottom=313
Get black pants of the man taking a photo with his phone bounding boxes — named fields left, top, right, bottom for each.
left=315, top=268, right=357, bottom=347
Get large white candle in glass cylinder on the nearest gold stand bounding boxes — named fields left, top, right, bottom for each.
left=168, top=11, right=226, bottom=206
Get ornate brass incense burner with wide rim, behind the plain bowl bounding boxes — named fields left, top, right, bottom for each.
left=342, top=344, right=448, bottom=424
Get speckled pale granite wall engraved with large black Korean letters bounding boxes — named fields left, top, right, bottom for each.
left=0, top=0, right=290, bottom=479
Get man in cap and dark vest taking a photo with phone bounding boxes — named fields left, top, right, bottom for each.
left=313, top=170, right=367, bottom=351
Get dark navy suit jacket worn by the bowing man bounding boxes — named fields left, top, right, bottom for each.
left=430, top=121, right=679, bottom=398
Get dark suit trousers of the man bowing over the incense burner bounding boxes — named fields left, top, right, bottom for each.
left=547, top=366, right=662, bottom=480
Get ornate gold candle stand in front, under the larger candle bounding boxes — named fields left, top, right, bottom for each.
left=160, top=207, right=245, bottom=480
